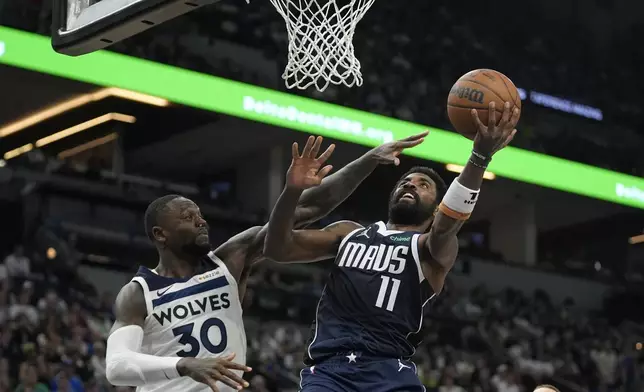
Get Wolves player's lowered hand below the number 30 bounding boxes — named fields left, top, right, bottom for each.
left=177, top=353, right=252, bottom=392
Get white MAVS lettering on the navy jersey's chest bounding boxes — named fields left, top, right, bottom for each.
left=338, top=242, right=409, bottom=274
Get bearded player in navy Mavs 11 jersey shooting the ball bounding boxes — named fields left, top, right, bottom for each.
left=264, top=103, right=519, bottom=392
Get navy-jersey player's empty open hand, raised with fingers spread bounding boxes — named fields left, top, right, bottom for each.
left=286, top=136, right=335, bottom=190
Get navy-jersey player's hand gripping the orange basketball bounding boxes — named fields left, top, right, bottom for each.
left=472, top=101, right=521, bottom=158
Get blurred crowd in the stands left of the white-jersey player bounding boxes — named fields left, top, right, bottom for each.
left=0, top=246, right=122, bottom=392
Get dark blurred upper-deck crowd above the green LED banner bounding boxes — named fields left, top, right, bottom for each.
left=0, top=0, right=644, bottom=174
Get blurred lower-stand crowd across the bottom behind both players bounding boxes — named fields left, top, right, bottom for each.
left=0, top=237, right=644, bottom=392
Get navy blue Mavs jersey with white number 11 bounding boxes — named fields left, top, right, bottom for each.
left=305, top=222, right=434, bottom=365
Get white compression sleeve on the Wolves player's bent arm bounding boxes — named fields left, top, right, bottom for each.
left=105, top=325, right=181, bottom=387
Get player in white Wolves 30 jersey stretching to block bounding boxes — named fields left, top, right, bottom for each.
left=106, top=133, right=426, bottom=392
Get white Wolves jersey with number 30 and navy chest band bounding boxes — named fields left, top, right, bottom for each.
left=132, top=252, right=246, bottom=392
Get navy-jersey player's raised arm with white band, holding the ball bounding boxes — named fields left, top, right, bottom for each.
left=424, top=102, right=520, bottom=287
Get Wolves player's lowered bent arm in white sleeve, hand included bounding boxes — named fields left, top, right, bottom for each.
left=106, top=282, right=250, bottom=392
